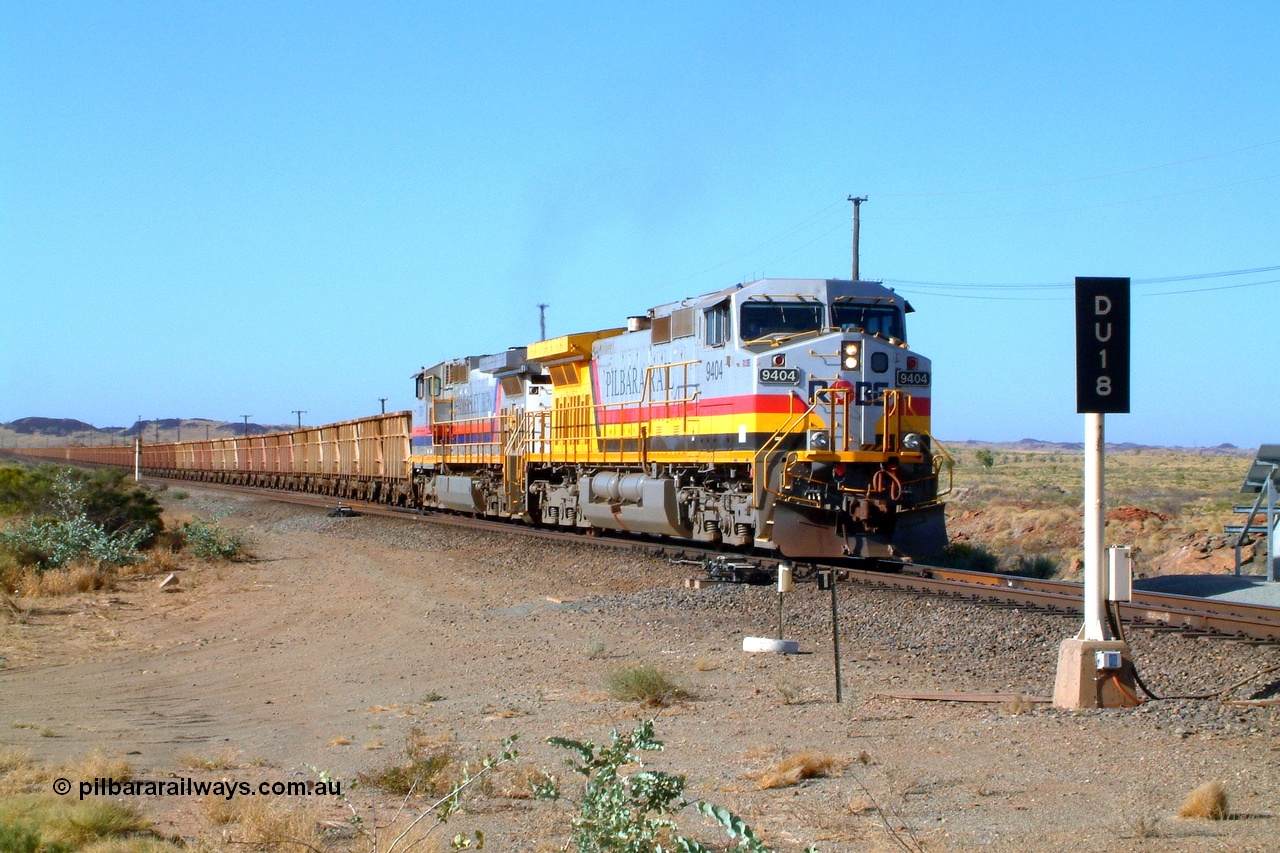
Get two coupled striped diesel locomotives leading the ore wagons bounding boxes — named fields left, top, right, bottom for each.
left=407, top=279, right=948, bottom=561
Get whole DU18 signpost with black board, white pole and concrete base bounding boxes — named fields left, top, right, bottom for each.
left=1053, top=278, right=1134, bottom=708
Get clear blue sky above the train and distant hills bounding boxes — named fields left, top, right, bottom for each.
left=0, top=0, right=1280, bottom=447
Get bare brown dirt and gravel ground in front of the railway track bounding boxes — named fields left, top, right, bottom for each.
left=0, top=489, right=1280, bottom=850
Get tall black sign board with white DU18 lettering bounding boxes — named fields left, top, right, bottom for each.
left=1075, top=278, right=1129, bottom=414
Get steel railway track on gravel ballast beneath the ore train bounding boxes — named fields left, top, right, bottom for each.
left=157, top=476, right=1280, bottom=643
